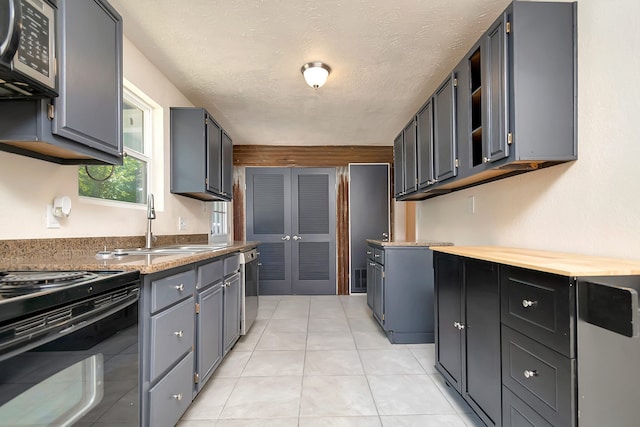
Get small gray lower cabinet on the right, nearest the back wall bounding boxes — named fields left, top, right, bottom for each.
left=367, top=244, right=434, bottom=344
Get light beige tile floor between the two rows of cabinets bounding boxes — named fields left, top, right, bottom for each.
left=178, top=295, right=483, bottom=427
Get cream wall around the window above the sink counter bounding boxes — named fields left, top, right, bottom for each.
left=0, top=39, right=211, bottom=239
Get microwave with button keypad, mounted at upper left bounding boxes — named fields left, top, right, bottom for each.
left=0, top=0, right=58, bottom=98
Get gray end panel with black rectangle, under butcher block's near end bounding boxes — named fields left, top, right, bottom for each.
left=577, top=276, right=640, bottom=427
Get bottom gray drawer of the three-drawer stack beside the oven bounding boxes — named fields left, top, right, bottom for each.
left=149, top=352, right=193, bottom=427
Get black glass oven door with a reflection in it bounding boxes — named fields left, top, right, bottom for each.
left=0, top=299, right=139, bottom=426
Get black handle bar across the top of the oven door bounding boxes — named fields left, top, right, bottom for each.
left=0, top=286, right=139, bottom=361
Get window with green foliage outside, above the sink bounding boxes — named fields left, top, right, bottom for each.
left=78, top=87, right=153, bottom=204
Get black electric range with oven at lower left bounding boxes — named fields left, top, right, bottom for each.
left=0, top=271, right=140, bottom=426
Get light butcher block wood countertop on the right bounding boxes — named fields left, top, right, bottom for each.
left=432, top=246, right=640, bottom=276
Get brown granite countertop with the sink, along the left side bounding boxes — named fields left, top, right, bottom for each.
left=0, top=241, right=260, bottom=274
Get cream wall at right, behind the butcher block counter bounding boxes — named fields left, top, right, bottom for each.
left=417, top=0, right=640, bottom=259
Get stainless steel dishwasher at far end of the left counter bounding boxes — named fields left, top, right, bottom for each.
left=240, top=249, right=259, bottom=335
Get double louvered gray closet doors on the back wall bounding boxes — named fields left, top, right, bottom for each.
left=246, top=168, right=336, bottom=295
